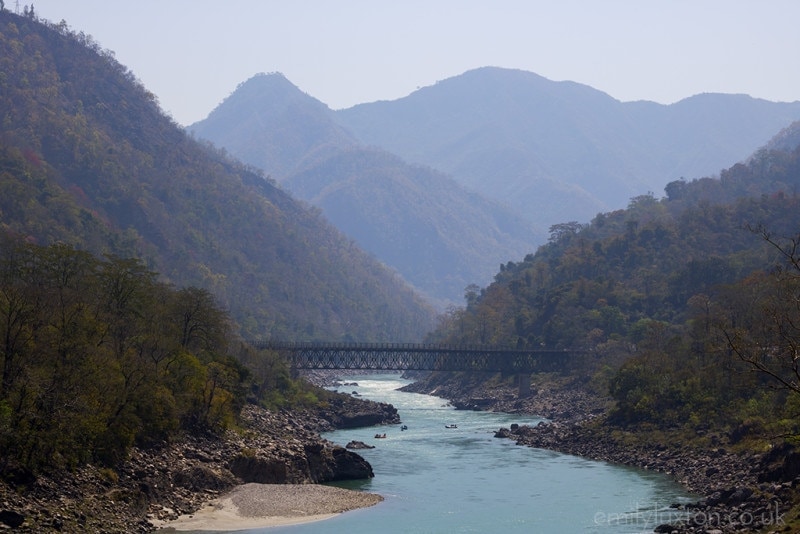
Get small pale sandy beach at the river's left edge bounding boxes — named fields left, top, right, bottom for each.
left=157, top=484, right=383, bottom=532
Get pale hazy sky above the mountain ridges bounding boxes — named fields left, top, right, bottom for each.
left=25, top=0, right=800, bottom=125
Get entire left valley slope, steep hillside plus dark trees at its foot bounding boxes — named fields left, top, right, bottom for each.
left=0, top=10, right=432, bottom=484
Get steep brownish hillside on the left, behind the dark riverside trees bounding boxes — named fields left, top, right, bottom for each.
left=0, top=11, right=434, bottom=341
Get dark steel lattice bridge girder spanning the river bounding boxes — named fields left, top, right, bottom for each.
left=253, top=341, right=584, bottom=373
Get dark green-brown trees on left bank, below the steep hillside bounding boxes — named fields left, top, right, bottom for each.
left=0, top=235, right=319, bottom=475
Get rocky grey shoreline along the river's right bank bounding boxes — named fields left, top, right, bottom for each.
left=405, top=375, right=800, bottom=534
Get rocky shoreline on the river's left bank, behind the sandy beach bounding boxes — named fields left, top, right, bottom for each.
left=0, top=395, right=398, bottom=533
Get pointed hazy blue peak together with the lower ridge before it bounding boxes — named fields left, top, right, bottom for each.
left=188, top=74, right=545, bottom=309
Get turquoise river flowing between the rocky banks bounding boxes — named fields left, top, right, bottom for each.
left=249, top=375, right=691, bottom=534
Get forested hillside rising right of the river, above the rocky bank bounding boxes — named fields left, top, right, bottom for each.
left=430, top=140, right=800, bottom=438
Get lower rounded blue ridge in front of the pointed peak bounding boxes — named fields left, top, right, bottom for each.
left=284, top=148, right=541, bottom=309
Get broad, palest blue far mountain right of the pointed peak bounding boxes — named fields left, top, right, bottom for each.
left=336, top=67, right=800, bottom=228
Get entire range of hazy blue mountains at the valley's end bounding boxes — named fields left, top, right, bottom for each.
left=188, top=67, right=800, bottom=308
